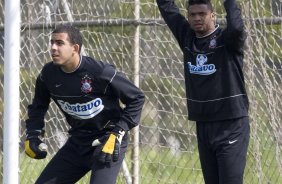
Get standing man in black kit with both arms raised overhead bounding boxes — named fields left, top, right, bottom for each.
left=157, top=0, right=250, bottom=184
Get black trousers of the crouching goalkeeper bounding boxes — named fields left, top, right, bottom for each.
left=36, top=136, right=127, bottom=184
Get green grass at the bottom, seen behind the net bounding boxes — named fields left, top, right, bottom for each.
left=14, top=141, right=282, bottom=184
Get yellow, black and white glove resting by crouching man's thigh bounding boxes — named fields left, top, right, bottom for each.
left=92, top=130, right=125, bottom=163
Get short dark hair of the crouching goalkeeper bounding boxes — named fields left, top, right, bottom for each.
left=52, top=24, right=82, bottom=53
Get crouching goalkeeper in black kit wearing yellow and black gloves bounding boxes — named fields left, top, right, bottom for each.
left=25, top=25, right=145, bottom=184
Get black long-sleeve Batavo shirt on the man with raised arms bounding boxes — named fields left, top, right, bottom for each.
left=157, top=0, right=249, bottom=121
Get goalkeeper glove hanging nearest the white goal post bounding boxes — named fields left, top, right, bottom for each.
left=24, top=130, right=47, bottom=159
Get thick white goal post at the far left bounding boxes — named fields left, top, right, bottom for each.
left=3, top=0, right=21, bottom=184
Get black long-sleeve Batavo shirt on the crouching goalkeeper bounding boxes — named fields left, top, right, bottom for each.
left=26, top=56, right=145, bottom=137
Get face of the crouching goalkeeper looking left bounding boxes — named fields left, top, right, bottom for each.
left=51, top=33, right=78, bottom=67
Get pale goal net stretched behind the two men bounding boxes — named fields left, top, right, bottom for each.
left=0, top=0, right=282, bottom=184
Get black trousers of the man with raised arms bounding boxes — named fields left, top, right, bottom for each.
left=197, top=117, right=250, bottom=184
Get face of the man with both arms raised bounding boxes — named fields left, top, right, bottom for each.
left=188, top=4, right=215, bottom=36
